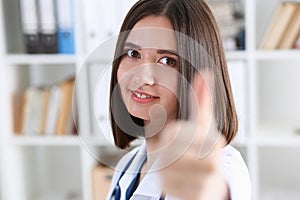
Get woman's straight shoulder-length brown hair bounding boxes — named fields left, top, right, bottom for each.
left=110, top=0, right=238, bottom=149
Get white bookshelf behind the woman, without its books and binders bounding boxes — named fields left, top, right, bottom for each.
left=0, top=0, right=300, bottom=200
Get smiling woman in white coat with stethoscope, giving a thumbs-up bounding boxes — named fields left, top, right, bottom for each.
left=107, top=0, right=251, bottom=200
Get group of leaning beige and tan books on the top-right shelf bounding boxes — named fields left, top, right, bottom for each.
left=259, top=2, right=300, bottom=50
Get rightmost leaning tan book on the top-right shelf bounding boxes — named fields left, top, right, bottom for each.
left=278, top=3, right=300, bottom=49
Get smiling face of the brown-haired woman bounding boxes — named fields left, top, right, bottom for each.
left=117, top=16, right=178, bottom=122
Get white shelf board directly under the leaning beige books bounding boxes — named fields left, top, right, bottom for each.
left=255, top=49, right=300, bottom=60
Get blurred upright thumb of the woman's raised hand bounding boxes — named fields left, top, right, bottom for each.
left=189, top=71, right=225, bottom=159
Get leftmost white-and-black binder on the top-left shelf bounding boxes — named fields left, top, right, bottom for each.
left=20, top=0, right=42, bottom=54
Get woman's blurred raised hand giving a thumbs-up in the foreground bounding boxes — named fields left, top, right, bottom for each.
left=159, top=73, right=228, bottom=200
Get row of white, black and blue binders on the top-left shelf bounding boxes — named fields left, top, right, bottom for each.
left=20, top=0, right=74, bottom=54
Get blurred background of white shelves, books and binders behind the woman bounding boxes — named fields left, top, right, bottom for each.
left=0, top=0, right=300, bottom=200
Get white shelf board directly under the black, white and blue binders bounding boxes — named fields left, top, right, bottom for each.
left=6, top=54, right=76, bottom=65
